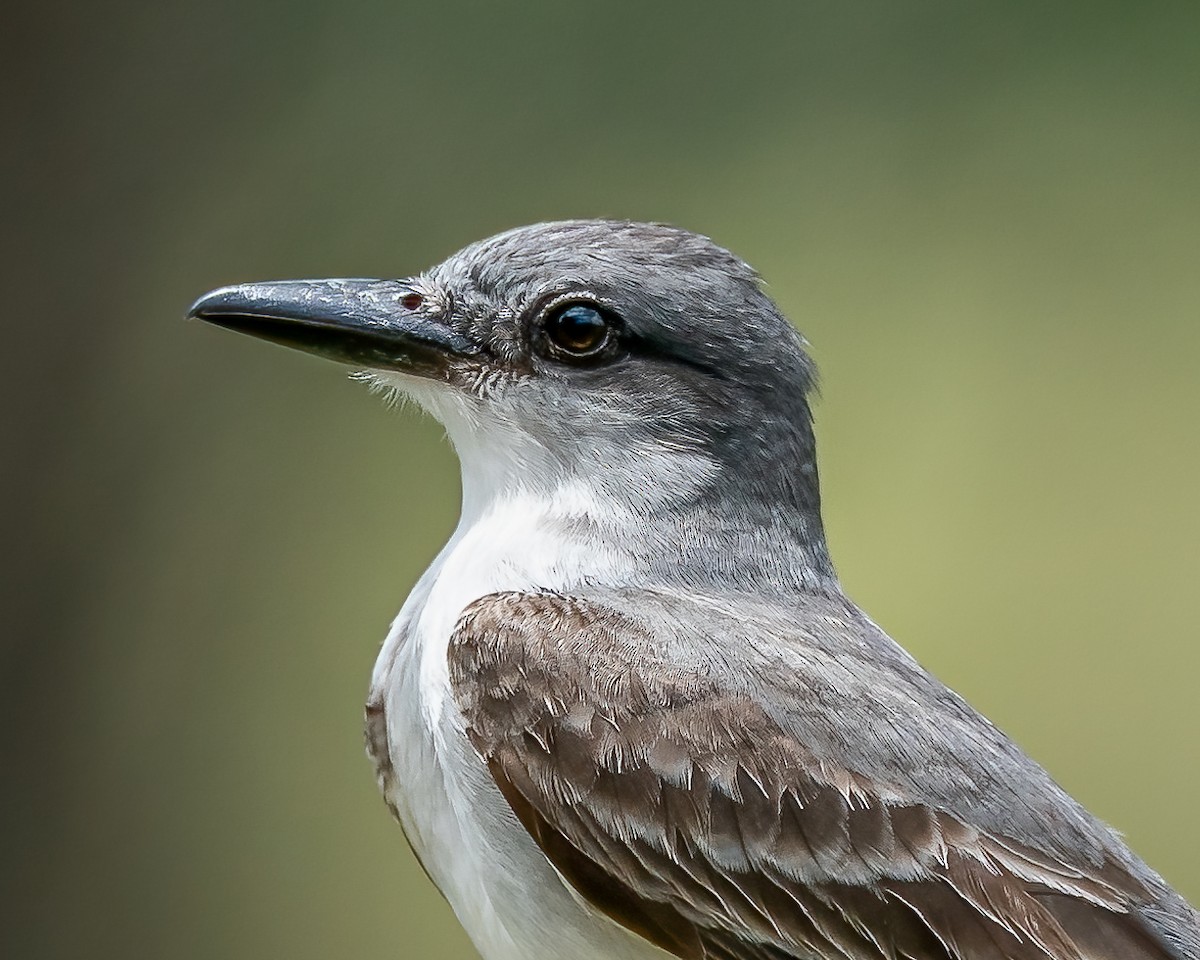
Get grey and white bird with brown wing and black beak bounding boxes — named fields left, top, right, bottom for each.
left=188, top=220, right=1200, bottom=960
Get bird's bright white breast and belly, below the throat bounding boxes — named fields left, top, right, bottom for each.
left=371, top=490, right=665, bottom=960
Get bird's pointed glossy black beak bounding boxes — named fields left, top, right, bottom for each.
left=187, top=280, right=479, bottom=376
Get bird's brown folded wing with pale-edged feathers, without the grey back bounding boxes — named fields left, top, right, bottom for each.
left=450, top=594, right=1171, bottom=960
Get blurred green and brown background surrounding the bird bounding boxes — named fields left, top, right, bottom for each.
left=0, top=0, right=1200, bottom=960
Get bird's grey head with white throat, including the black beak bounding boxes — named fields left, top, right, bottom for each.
left=190, top=221, right=840, bottom=580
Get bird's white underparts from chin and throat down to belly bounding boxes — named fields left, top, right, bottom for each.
left=371, top=372, right=712, bottom=960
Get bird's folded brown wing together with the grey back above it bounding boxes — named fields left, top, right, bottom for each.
left=449, top=594, right=1182, bottom=960
